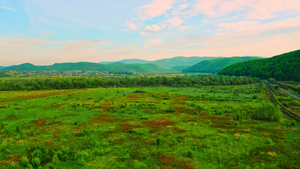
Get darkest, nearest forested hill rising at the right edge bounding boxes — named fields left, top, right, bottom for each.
left=218, top=50, right=300, bottom=82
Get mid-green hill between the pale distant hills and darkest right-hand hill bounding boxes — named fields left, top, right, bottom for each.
left=182, top=57, right=259, bottom=73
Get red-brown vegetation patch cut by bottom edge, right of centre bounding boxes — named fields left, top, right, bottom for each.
left=158, top=154, right=194, bottom=169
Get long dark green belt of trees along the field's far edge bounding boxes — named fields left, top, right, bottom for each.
left=0, top=75, right=257, bottom=91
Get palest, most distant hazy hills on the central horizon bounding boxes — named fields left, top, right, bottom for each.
left=100, top=56, right=220, bottom=69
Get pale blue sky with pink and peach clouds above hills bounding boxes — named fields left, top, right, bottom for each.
left=0, top=0, right=300, bottom=66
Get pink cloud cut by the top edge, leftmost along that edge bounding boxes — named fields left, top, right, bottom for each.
left=139, top=0, right=174, bottom=19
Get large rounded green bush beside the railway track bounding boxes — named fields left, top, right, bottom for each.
left=252, top=103, right=282, bottom=121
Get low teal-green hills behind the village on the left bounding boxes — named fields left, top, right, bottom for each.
left=3, top=62, right=175, bottom=73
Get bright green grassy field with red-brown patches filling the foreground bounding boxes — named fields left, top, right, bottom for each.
left=0, top=84, right=300, bottom=169
